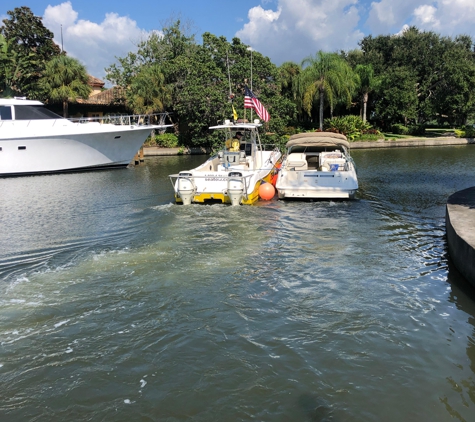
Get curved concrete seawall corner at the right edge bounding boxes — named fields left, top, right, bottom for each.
left=445, top=186, right=475, bottom=287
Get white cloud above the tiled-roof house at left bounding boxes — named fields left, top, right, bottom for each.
left=43, top=1, right=148, bottom=82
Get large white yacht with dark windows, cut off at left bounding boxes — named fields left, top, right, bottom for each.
left=0, top=98, right=171, bottom=176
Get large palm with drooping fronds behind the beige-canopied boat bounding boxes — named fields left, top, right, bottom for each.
left=297, top=50, right=355, bottom=130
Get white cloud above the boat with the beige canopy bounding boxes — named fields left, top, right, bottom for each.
left=236, top=0, right=364, bottom=64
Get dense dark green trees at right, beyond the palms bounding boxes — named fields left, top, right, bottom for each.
left=358, top=27, right=475, bottom=128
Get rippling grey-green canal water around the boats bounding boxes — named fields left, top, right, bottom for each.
left=0, top=146, right=475, bottom=422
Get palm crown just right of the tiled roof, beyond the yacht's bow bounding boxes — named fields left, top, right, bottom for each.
left=127, top=64, right=171, bottom=114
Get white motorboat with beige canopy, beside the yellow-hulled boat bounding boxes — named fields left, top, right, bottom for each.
left=276, top=132, right=358, bottom=199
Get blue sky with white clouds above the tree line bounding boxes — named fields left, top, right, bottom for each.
left=0, top=0, right=475, bottom=83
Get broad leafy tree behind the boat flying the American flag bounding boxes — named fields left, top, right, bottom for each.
left=106, top=21, right=295, bottom=147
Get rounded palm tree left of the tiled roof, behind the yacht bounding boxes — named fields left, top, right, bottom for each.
left=39, top=54, right=91, bottom=117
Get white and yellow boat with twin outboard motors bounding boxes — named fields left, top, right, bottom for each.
left=170, top=119, right=282, bottom=205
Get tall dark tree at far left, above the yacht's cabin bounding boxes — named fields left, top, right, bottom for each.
left=0, top=6, right=61, bottom=98
